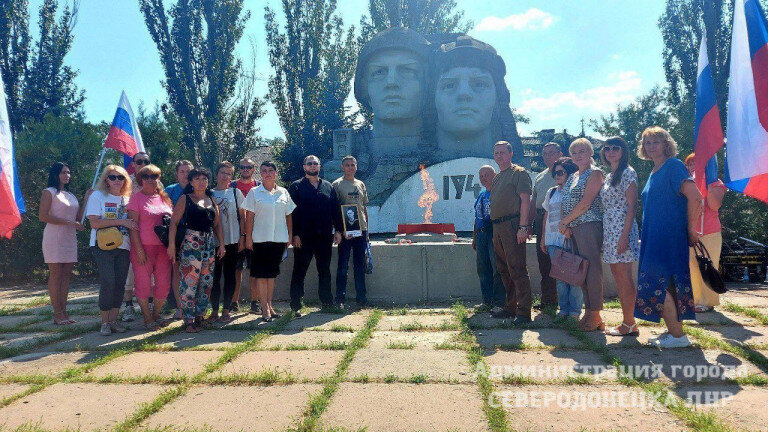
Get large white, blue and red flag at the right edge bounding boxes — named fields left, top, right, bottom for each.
left=724, top=0, right=768, bottom=203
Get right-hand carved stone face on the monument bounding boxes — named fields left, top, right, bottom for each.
left=435, top=67, right=496, bottom=135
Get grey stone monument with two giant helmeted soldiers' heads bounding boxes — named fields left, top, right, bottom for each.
left=324, top=27, right=528, bottom=232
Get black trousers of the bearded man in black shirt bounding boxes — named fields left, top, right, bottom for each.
left=291, top=233, right=333, bottom=310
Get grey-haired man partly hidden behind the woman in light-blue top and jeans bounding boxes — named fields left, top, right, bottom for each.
left=528, top=142, right=563, bottom=309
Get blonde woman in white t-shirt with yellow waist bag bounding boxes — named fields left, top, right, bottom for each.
left=85, top=165, right=136, bottom=336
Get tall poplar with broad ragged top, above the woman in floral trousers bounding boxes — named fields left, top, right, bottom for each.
left=139, top=0, right=264, bottom=172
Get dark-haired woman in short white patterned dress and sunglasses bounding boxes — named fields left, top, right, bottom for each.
left=600, top=137, right=640, bottom=336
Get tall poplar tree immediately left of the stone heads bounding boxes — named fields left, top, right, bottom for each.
left=265, top=0, right=357, bottom=179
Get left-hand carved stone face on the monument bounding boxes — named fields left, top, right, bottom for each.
left=366, top=49, right=424, bottom=122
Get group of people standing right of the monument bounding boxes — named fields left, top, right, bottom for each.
left=473, top=126, right=725, bottom=348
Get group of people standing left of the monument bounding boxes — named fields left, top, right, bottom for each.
left=39, top=152, right=368, bottom=336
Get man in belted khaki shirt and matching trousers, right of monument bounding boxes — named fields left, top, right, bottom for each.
left=491, top=141, right=531, bottom=325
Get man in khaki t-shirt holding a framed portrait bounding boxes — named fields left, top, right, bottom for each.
left=333, top=156, right=368, bottom=309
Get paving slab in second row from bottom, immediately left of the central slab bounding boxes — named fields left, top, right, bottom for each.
left=213, top=350, right=344, bottom=381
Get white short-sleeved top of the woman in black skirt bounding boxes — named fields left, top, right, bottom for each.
left=243, top=185, right=296, bottom=243
